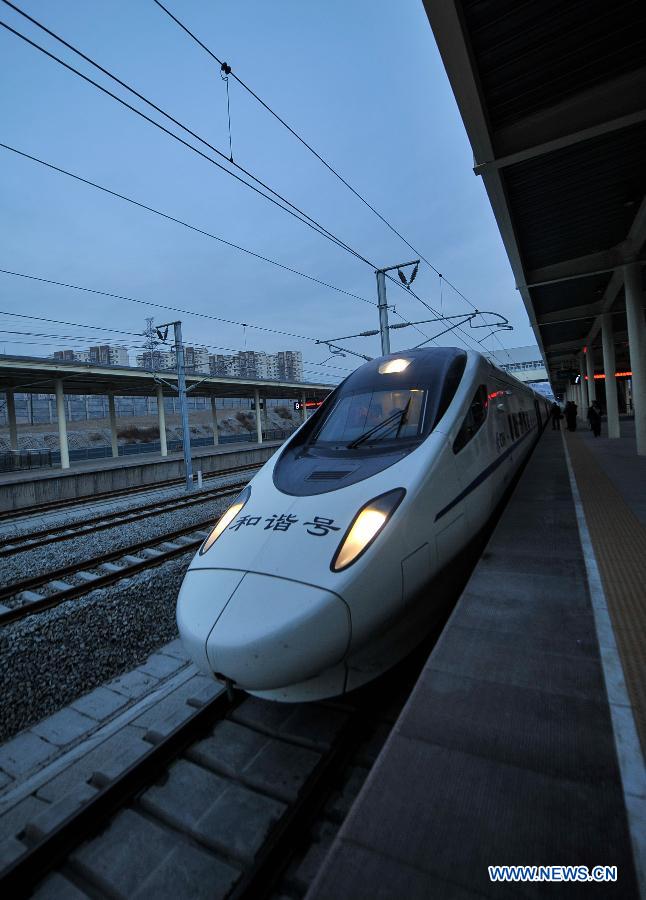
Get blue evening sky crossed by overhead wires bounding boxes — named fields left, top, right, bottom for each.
left=0, top=0, right=534, bottom=381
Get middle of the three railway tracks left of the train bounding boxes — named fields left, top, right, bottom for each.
left=0, top=474, right=259, bottom=559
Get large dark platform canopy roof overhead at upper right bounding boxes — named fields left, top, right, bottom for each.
left=424, top=0, right=646, bottom=390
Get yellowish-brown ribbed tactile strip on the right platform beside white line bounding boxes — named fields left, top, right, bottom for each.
left=567, top=434, right=646, bottom=756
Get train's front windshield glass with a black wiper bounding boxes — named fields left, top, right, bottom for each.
left=310, top=388, right=426, bottom=449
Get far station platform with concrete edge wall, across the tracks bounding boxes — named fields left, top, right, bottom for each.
left=0, top=441, right=281, bottom=512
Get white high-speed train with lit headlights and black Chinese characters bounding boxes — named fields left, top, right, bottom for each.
left=177, top=348, right=549, bottom=701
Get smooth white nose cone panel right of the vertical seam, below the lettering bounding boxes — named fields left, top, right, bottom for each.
left=206, top=573, right=350, bottom=690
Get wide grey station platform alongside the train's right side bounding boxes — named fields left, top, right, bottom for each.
left=307, top=429, right=646, bottom=900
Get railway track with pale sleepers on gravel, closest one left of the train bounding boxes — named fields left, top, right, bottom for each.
left=0, top=512, right=225, bottom=626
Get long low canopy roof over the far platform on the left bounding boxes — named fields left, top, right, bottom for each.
left=0, top=356, right=334, bottom=400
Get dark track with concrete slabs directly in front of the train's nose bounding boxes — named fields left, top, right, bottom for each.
left=0, top=651, right=420, bottom=900
